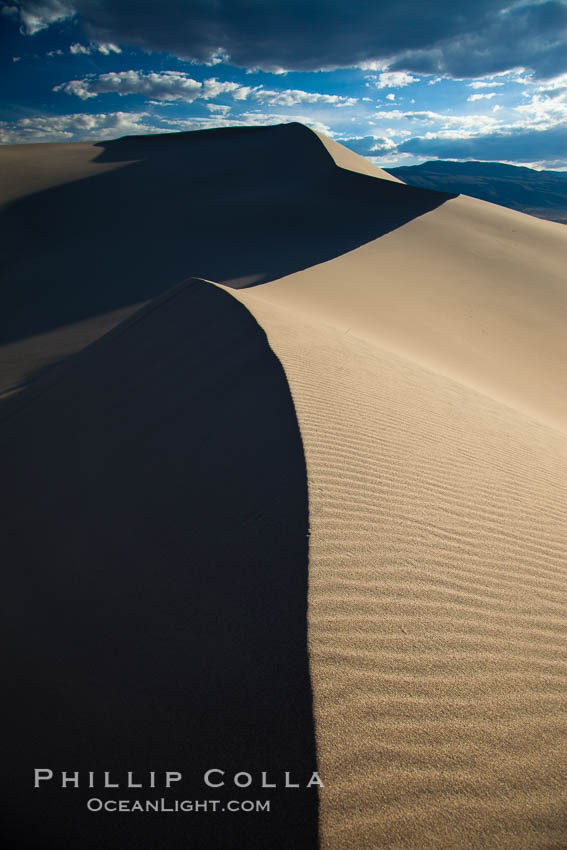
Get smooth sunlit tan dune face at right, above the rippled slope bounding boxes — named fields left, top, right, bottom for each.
left=247, top=196, right=567, bottom=428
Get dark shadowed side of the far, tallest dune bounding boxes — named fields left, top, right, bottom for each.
left=0, top=124, right=454, bottom=344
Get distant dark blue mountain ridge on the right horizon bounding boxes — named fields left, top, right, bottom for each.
left=389, top=161, right=567, bottom=224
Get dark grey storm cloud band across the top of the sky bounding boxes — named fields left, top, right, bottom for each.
left=8, top=0, right=567, bottom=78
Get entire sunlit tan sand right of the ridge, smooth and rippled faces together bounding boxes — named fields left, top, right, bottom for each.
left=231, top=132, right=567, bottom=850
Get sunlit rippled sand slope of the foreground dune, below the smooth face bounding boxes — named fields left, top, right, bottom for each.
left=233, top=282, right=567, bottom=850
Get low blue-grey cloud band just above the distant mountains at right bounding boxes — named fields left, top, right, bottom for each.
left=396, top=124, right=567, bottom=164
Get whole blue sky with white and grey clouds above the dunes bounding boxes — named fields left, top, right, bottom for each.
left=0, top=0, right=567, bottom=170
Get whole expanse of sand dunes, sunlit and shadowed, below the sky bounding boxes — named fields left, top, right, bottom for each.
left=0, top=125, right=567, bottom=850
